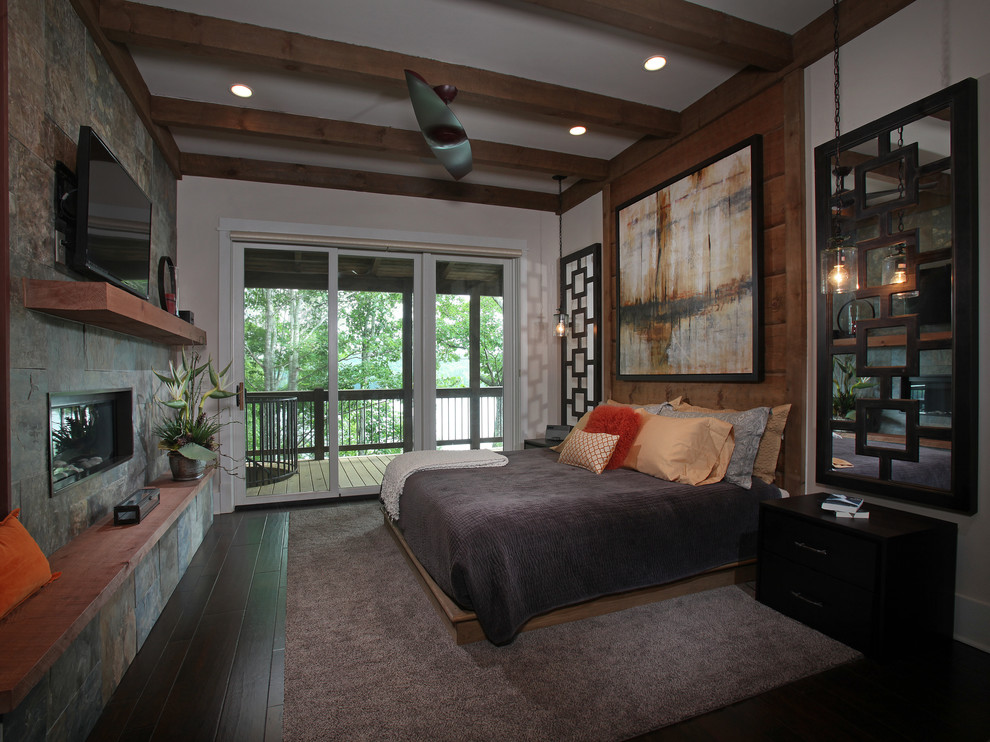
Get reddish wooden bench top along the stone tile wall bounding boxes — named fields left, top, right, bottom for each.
left=0, top=472, right=213, bottom=714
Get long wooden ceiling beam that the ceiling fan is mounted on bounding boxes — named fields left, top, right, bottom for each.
left=100, top=0, right=680, bottom=136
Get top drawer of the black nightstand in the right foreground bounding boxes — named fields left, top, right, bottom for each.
left=762, top=511, right=878, bottom=591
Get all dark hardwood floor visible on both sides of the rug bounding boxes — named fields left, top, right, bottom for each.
left=89, top=503, right=990, bottom=742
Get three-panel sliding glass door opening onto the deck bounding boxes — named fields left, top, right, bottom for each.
left=231, top=243, right=506, bottom=505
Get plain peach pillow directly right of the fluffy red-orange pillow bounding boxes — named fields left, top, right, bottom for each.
left=623, top=410, right=735, bottom=485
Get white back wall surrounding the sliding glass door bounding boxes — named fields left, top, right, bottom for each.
left=176, top=177, right=602, bottom=506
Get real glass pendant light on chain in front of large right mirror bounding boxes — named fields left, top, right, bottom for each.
left=819, top=0, right=859, bottom=294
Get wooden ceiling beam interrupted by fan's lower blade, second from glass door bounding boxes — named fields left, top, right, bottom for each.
left=151, top=97, right=608, bottom=180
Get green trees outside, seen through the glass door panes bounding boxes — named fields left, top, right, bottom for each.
left=244, top=288, right=503, bottom=454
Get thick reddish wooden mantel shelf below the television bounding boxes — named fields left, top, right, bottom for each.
left=24, top=278, right=206, bottom=345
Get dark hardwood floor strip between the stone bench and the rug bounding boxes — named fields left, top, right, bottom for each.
left=89, top=510, right=289, bottom=742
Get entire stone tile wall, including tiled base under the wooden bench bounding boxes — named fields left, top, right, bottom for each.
left=0, top=0, right=213, bottom=742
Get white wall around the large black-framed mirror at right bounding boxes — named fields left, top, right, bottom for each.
left=805, top=0, right=990, bottom=651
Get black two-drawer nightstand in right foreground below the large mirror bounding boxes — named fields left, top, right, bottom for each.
left=756, top=494, right=956, bottom=657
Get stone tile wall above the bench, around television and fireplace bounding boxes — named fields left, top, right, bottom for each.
left=8, top=0, right=176, bottom=554
